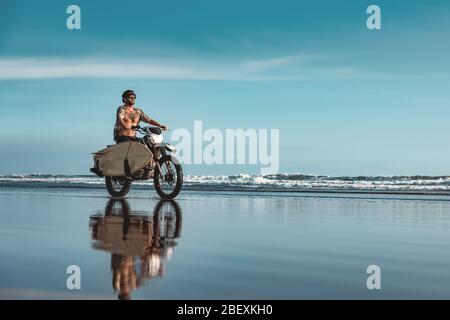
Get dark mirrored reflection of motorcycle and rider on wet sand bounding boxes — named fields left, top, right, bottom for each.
left=89, top=199, right=182, bottom=300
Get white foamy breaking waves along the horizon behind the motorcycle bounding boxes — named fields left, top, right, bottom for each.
left=0, top=173, right=450, bottom=194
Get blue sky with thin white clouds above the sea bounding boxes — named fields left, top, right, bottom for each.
left=0, top=0, right=450, bottom=175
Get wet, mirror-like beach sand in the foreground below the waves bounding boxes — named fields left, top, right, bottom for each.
left=0, top=187, right=450, bottom=299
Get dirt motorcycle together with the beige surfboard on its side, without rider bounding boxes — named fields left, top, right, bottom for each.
left=90, top=126, right=183, bottom=199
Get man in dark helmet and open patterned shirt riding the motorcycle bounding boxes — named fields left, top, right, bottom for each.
left=114, top=90, right=169, bottom=143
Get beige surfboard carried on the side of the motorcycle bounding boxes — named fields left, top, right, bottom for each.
left=94, top=141, right=153, bottom=177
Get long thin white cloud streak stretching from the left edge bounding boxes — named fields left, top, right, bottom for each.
left=0, top=55, right=386, bottom=81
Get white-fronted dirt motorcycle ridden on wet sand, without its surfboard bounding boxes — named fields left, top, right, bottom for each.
left=90, top=126, right=183, bottom=199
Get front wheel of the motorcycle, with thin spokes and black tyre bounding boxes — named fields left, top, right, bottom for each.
left=153, top=155, right=183, bottom=199
